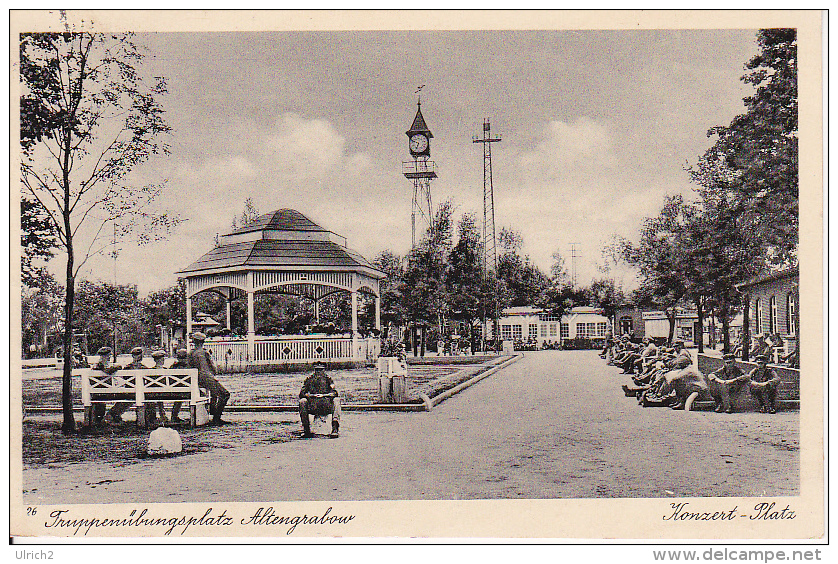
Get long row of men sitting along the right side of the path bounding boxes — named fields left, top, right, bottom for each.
left=600, top=337, right=780, bottom=413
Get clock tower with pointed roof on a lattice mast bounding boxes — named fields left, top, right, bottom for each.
left=402, top=100, right=436, bottom=247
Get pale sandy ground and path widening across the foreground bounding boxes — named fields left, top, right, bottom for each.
left=18, top=351, right=800, bottom=504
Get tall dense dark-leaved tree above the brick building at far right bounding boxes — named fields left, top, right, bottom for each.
left=691, top=29, right=799, bottom=264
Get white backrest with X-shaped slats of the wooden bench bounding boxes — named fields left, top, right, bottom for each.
left=79, top=368, right=200, bottom=405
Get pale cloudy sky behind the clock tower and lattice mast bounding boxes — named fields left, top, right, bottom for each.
left=65, top=30, right=756, bottom=293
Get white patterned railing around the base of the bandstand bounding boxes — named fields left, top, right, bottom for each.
left=204, top=335, right=381, bottom=371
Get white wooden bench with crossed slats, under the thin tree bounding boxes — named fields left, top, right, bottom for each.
left=78, top=368, right=209, bottom=427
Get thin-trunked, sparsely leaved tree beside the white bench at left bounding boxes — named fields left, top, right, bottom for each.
left=20, top=31, right=178, bottom=433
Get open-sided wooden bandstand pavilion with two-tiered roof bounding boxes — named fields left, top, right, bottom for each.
left=177, top=209, right=385, bottom=366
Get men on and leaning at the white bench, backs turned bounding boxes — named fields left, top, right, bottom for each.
left=93, top=332, right=230, bottom=426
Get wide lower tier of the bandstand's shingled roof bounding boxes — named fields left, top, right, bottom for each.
left=179, top=239, right=384, bottom=278
